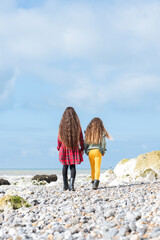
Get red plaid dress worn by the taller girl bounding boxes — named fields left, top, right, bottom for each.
left=57, top=131, right=84, bottom=165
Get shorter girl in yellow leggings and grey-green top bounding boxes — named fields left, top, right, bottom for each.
left=84, top=118, right=113, bottom=189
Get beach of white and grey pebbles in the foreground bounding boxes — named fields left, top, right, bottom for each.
left=0, top=176, right=160, bottom=240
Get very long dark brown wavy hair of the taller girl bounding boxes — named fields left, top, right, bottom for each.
left=58, top=107, right=81, bottom=149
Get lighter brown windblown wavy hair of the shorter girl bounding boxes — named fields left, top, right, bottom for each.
left=85, top=118, right=113, bottom=144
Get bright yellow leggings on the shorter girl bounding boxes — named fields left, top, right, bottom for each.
left=88, top=149, right=102, bottom=181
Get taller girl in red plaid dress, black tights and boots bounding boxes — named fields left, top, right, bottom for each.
left=57, top=107, right=84, bottom=191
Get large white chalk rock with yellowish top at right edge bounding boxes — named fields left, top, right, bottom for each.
left=100, top=151, right=160, bottom=186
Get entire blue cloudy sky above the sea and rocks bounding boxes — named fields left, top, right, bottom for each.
left=0, top=0, right=160, bottom=169
